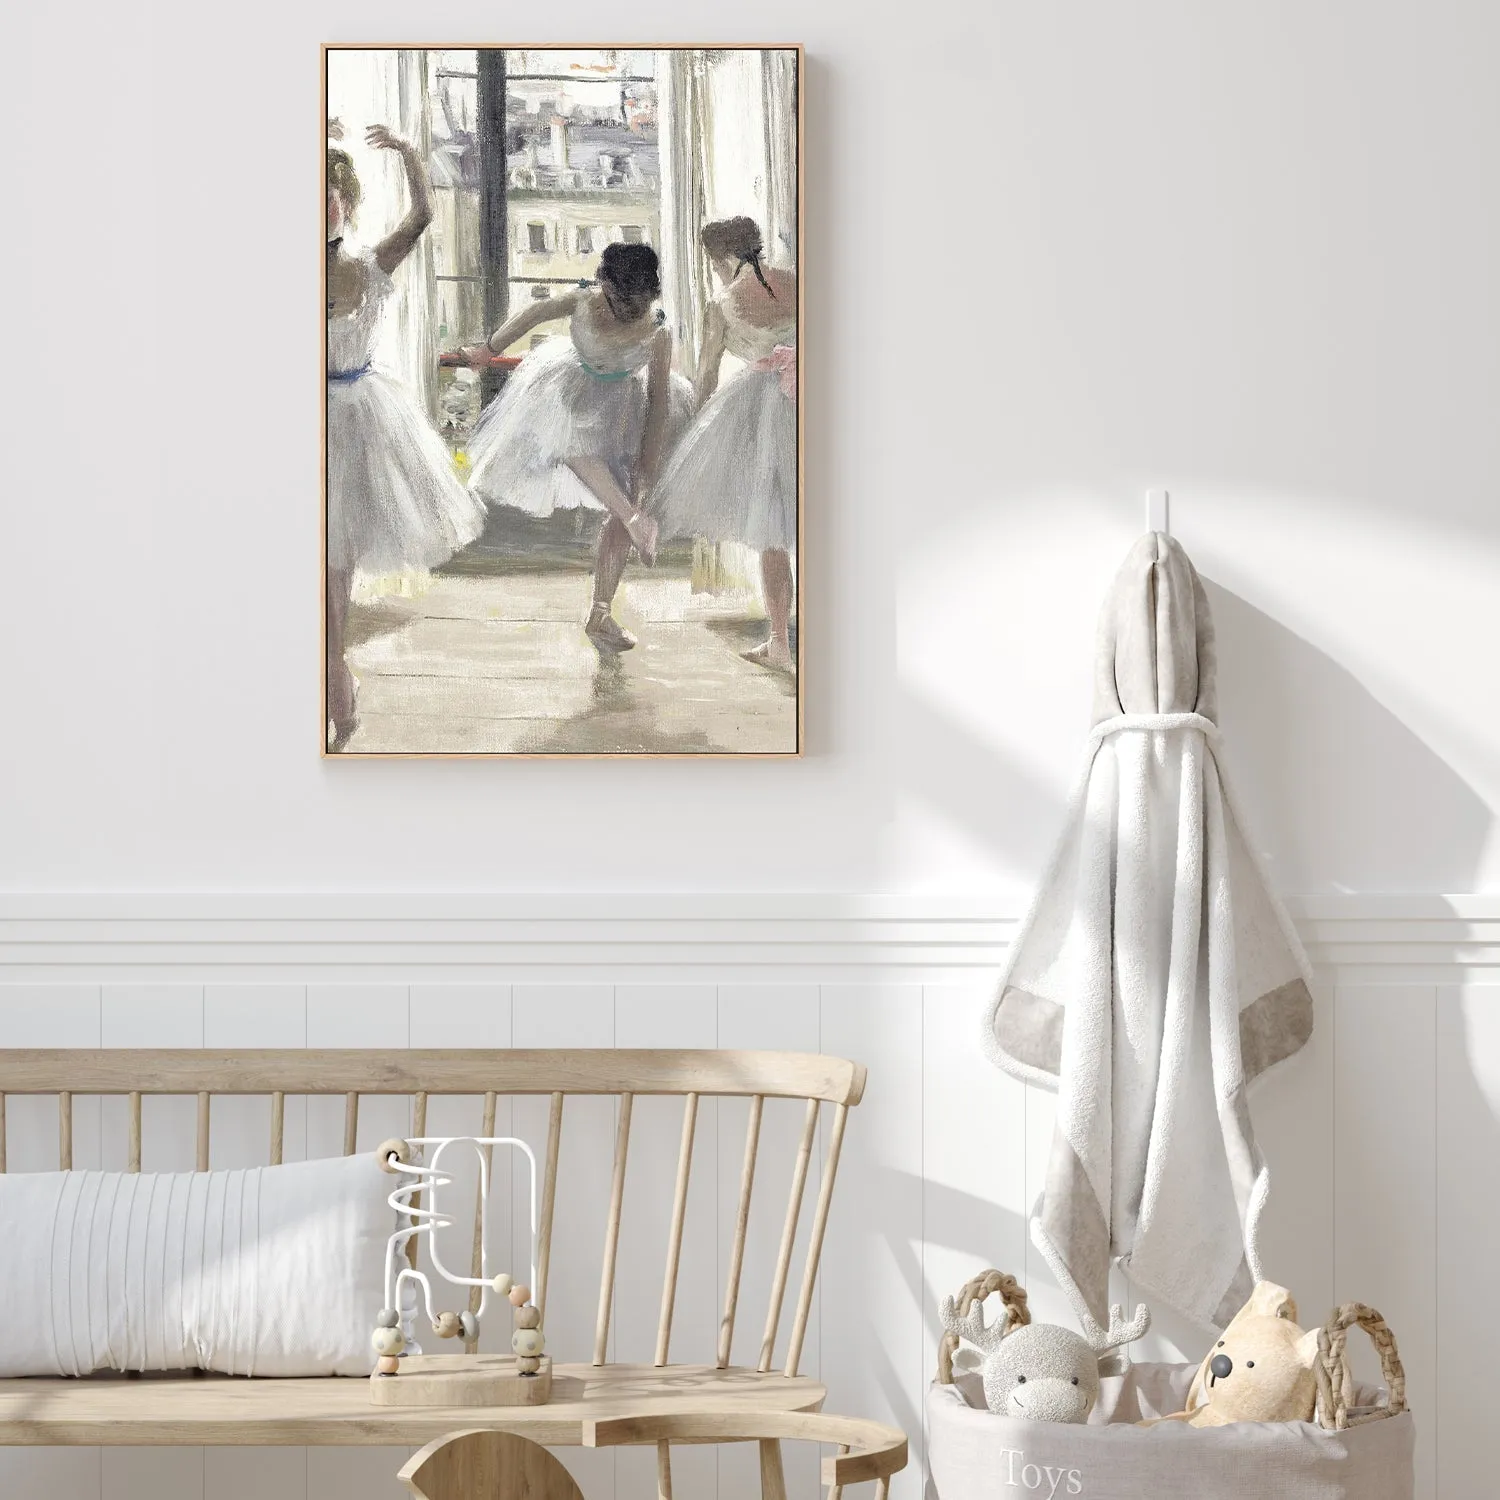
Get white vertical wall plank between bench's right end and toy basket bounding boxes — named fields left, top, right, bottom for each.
left=821, top=984, right=927, bottom=1500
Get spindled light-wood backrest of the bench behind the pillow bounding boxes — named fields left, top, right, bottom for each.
left=0, top=1049, right=864, bottom=1376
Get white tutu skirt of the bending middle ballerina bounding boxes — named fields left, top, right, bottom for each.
left=468, top=328, right=693, bottom=516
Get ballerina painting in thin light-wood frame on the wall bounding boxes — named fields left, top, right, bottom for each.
left=320, top=45, right=803, bottom=758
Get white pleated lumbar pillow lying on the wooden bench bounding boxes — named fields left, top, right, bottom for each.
left=0, top=1152, right=396, bottom=1376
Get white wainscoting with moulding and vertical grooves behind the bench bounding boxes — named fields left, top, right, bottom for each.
left=0, top=899, right=1500, bottom=1500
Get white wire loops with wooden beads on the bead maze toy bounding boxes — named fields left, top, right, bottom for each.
left=371, top=1136, right=546, bottom=1376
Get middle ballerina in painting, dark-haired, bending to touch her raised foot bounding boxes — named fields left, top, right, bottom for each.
left=464, top=243, right=693, bottom=651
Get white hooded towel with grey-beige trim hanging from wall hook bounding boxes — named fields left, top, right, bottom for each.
left=984, top=534, right=1313, bottom=1328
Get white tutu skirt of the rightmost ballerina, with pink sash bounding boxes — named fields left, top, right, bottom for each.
left=651, top=369, right=797, bottom=552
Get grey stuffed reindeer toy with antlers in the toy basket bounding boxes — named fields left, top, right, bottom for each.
left=942, top=1277, right=1151, bottom=1422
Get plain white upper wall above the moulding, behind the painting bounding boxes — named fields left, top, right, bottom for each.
left=0, top=0, right=1500, bottom=893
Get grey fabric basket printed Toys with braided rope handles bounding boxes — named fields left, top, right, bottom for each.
left=927, top=1274, right=1416, bottom=1500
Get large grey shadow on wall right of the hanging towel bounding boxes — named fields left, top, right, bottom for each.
left=1205, top=579, right=1491, bottom=893
